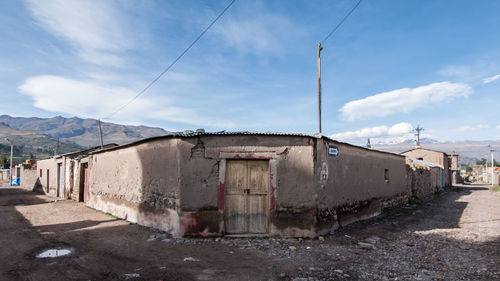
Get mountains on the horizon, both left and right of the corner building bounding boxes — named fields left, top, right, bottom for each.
left=0, top=115, right=500, bottom=164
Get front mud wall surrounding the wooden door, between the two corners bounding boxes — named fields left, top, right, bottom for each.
left=178, top=135, right=316, bottom=236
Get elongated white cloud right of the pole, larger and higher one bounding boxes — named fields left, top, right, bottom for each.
left=339, top=82, right=473, bottom=121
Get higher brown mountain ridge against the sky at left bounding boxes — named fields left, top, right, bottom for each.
left=0, top=115, right=168, bottom=147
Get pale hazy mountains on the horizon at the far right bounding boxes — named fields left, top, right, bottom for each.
left=372, top=140, right=500, bottom=164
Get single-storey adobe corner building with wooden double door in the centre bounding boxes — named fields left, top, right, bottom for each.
left=79, top=132, right=410, bottom=237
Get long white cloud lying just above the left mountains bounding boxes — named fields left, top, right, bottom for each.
left=19, top=75, right=234, bottom=128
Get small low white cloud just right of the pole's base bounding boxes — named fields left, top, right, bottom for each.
left=330, top=122, right=413, bottom=140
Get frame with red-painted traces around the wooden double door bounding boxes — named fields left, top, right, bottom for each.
left=218, top=150, right=278, bottom=236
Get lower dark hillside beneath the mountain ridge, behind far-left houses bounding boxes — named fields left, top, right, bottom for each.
left=0, top=122, right=86, bottom=166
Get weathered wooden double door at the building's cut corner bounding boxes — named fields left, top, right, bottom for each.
left=225, top=160, right=270, bottom=234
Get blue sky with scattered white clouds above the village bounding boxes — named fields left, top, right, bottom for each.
left=0, top=0, right=500, bottom=144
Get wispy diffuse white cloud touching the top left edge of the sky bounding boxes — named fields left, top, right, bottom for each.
left=25, top=0, right=132, bottom=65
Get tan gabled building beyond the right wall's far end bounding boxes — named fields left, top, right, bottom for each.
left=401, top=148, right=460, bottom=186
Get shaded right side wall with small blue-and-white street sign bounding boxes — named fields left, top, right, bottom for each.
left=315, top=139, right=410, bottom=233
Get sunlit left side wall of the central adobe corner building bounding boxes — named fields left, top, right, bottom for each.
left=87, top=139, right=180, bottom=233
